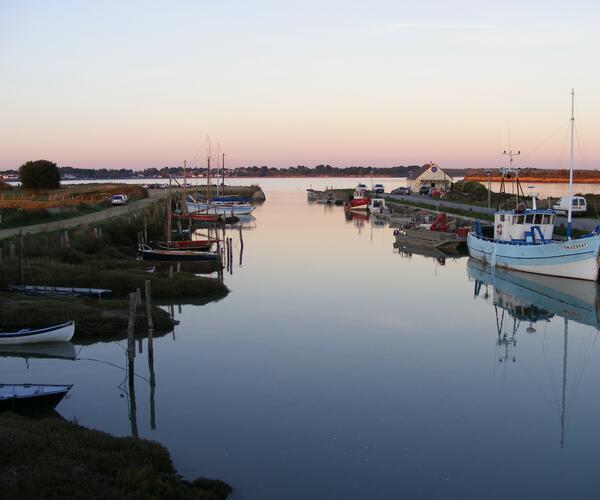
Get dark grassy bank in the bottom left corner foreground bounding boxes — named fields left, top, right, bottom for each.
left=0, top=413, right=231, bottom=500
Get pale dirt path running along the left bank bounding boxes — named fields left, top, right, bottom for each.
left=0, top=189, right=167, bottom=240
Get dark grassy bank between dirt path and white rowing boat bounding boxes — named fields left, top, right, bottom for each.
left=0, top=203, right=229, bottom=343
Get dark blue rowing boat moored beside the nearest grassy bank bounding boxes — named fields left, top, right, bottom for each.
left=0, top=384, right=73, bottom=413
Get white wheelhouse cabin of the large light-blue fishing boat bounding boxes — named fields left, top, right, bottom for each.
left=494, top=209, right=556, bottom=243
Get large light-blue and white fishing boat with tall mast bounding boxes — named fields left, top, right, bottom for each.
left=467, top=92, right=600, bottom=281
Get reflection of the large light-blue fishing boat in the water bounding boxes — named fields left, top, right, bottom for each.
left=467, top=259, right=600, bottom=448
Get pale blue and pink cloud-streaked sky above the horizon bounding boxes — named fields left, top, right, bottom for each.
left=0, top=0, right=600, bottom=169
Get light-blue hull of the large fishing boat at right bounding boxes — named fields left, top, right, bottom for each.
left=467, top=233, right=600, bottom=281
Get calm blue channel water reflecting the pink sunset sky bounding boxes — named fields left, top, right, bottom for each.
left=1, top=179, right=600, bottom=500
